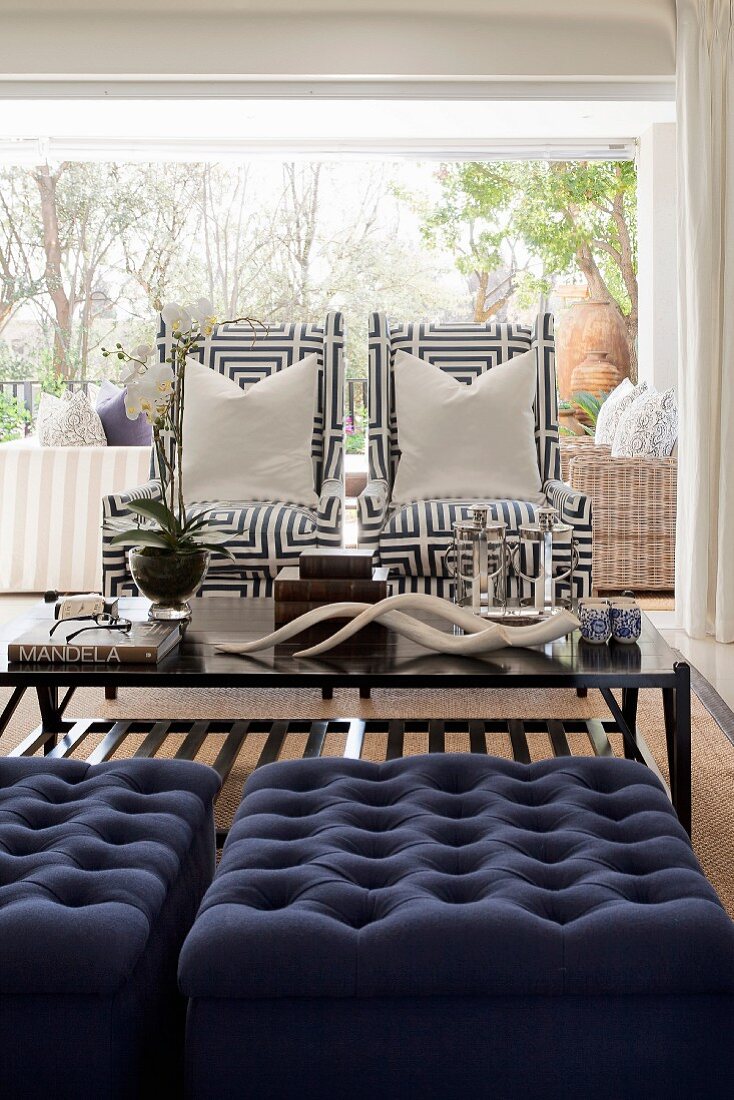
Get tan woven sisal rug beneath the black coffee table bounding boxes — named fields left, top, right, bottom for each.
left=0, top=674, right=734, bottom=916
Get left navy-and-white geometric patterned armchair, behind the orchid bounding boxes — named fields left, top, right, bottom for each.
left=102, top=312, right=344, bottom=596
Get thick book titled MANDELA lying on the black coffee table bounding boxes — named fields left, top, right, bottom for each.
left=8, top=620, right=180, bottom=664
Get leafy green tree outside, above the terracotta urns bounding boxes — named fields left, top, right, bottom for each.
left=403, top=161, right=638, bottom=370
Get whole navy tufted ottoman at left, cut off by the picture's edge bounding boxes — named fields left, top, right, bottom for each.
left=0, top=758, right=219, bottom=1100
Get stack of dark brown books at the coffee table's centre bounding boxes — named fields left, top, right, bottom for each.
left=273, top=549, right=388, bottom=627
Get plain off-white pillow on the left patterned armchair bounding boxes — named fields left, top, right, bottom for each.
left=183, top=355, right=318, bottom=508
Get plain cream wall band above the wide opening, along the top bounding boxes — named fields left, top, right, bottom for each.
left=0, top=0, right=675, bottom=79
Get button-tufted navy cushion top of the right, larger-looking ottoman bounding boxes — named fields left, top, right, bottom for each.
left=179, top=755, right=734, bottom=998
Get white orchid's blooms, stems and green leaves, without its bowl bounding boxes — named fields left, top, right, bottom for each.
left=102, top=298, right=261, bottom=558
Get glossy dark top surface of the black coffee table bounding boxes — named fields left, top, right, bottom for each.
left=0, top=596, right=679, bottom=688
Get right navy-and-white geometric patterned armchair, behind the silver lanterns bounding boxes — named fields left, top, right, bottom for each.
left=358, top=314, right=592, bottom=596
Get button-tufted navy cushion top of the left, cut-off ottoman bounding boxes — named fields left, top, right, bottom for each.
left=0, top=758, right=219, bottom=996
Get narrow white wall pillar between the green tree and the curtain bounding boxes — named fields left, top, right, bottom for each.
left=637, top=122, right=678, bottom=389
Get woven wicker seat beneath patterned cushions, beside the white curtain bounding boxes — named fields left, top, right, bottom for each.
left=568, top=446, right=678, bottom=592
